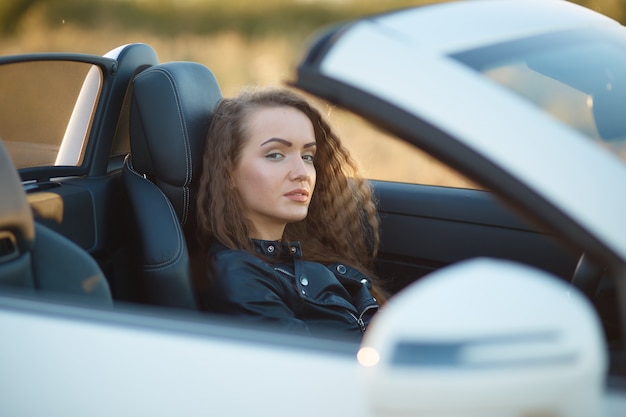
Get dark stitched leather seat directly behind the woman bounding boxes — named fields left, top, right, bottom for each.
left=123, top=62, right=222, bottom=309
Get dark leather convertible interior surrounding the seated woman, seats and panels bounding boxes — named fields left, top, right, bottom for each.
left=0, top=44, right=621, bottom=376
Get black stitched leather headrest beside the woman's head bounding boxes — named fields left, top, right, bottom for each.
left=130, top=62, right=222, bottom=226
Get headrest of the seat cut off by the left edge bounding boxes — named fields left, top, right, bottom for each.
left=0, top=140, right=35, bottom=256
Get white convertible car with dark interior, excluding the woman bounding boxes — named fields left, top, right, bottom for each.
left=0, top=0, right=626, bottom=417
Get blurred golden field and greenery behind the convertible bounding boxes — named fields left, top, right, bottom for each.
left=0, top=0, right=626, bottom=187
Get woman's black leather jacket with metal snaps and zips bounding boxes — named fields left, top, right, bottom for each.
left=203, top=240, right=378, bottom=340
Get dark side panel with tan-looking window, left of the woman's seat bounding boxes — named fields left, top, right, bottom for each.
left=0, top=44, right=157, bottom=299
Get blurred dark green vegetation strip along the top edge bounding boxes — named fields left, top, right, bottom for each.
left=0, top=0, right=437, bottom=37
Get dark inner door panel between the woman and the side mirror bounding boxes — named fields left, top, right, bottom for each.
left=373, top=181, right=578, bottom=293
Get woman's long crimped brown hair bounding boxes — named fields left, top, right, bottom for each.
left=197, top=88, right=386, bottom=302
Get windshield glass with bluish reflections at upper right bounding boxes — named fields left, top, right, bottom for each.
left=455, top=30, right=626, bottom=161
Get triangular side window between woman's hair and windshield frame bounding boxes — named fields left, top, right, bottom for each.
left=322, top=108, right=481, bottom=189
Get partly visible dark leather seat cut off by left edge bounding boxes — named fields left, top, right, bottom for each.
left=0, top=141, right=113, bottom=306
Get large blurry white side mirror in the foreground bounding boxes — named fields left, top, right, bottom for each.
left=358, top=258, right=607, bottom=417
